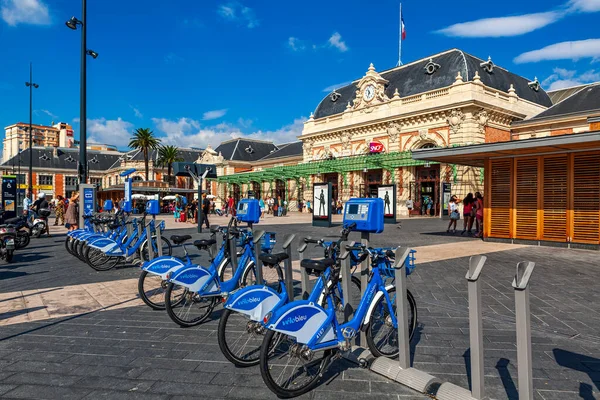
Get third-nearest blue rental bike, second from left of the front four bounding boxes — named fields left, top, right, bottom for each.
left=165, top=223, right=275, bottom=327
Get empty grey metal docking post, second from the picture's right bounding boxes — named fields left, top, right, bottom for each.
left=466, top=255, right=487, bottom=400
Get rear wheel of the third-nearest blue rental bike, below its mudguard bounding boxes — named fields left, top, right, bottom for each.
left=165, top=282, right=218, bottom=328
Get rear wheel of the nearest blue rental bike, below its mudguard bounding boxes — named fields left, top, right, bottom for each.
left=259, top=331, right=333, bottom=399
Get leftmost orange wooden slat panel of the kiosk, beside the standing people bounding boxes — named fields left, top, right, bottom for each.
left=489, top=159, right=513, bottom=238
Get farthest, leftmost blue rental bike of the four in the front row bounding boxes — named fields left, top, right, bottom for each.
left=138, top=226, right=237, bottom=310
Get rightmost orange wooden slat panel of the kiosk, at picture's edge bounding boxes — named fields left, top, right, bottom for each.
left=572, top=152, right=600, bottom=244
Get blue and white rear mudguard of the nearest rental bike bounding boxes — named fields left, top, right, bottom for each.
left=267, top=300, right=336, bottom=344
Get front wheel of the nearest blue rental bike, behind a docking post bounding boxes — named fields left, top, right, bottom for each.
left=367, top=287, right=417, bottom=358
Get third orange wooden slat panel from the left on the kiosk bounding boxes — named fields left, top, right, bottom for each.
left=541, top=154, right=568, bottom=242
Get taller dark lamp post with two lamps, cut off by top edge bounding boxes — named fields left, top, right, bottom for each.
left=65, top=0, right=98, bottom=184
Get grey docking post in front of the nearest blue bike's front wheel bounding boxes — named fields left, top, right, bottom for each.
left=394, top=246, right=410, bottom=369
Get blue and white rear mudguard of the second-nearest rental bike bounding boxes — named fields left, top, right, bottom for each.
left=224, top=285, right=287, bottom=322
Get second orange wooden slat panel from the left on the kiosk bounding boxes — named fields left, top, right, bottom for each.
left=515, top=157, right=538, bottom=240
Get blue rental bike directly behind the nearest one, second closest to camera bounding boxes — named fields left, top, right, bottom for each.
left=217, top=224, right=361, bottom=367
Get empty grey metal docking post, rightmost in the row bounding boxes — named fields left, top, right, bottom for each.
left=513, top=261, right=535, bottom=400
